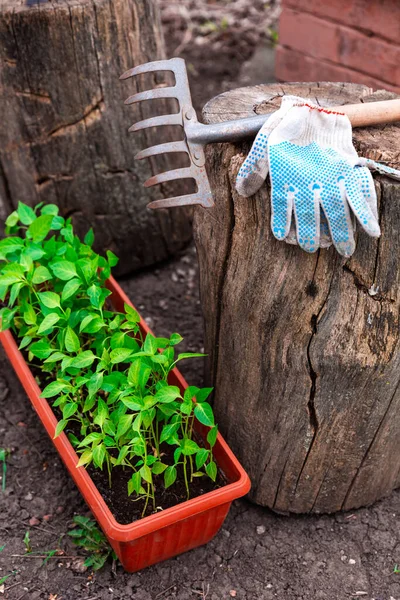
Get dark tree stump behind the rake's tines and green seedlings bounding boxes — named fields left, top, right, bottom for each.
left=0, top=0, right=191, bottom=274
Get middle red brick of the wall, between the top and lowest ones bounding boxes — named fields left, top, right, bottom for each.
left=279, top=8, right=400, bottom=86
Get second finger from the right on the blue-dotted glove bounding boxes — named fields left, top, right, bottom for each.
left=320, top=176, right=356, bottom=257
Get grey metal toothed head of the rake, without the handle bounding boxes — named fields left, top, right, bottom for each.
left=120, top=58, right=214, bottom=208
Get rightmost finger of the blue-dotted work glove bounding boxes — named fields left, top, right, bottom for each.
left=345, top=167, right=381, bottom=237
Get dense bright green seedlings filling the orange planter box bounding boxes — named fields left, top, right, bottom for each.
left=0, top=203, right=218, bottom=514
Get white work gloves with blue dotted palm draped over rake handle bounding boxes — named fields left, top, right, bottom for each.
left=236, top=97, right=400, bottom=257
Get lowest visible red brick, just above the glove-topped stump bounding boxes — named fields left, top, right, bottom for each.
left=275, top=46, right=400, bottom=93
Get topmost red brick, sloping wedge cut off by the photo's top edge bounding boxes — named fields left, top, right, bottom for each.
left=282, top=0, right=400, bottom=43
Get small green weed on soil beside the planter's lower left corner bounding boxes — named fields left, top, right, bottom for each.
left=68, top=516, right=117, bottom=571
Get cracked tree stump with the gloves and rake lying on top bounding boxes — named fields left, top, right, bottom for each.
left=194, top=83, right=400, bottom=513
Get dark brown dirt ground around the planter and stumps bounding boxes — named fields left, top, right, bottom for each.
left=0, top=0, right=400, bottom=600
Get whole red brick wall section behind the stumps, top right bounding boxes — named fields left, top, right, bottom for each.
left=275, top=0, right=400, bottom=93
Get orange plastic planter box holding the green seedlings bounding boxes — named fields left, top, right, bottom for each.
left=0, top=277, right=250, bottom=572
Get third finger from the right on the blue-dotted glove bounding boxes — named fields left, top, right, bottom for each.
left=289, top=183, right=320, bottom=253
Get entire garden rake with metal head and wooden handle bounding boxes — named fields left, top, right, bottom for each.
left=120, top=58, right=400, bottom=208
